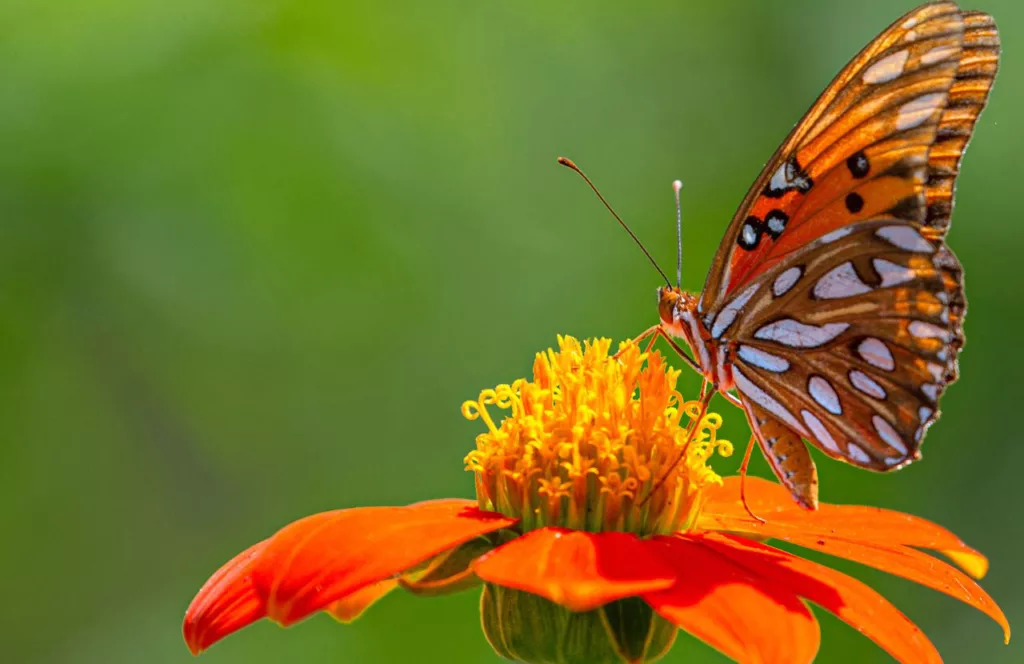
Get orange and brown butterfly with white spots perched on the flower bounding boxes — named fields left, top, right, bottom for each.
left=622, top=2, right=999, bottom=509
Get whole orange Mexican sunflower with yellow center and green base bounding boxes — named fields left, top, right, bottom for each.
left=184, top=337, right=1010, bottom=664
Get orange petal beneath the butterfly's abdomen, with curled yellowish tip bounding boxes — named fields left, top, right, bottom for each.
left=698, top=476, right=988, bottom=578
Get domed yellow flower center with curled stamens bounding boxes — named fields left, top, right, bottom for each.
left=462, top=336, right=732, bottom=535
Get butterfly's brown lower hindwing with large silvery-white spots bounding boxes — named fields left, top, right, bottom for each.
left=728, top=217, right=963, bottom=470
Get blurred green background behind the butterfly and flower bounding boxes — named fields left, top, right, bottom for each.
left=0, top=0, right=1024, bottom=664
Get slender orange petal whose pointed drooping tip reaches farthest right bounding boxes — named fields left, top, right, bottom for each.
left=768, top=522, right=1010, bottom=644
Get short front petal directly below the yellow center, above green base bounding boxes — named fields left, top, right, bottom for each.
left=473, top=528, right=676, bottom=611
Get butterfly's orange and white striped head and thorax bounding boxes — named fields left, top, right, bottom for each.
left=657, top=286, right=732, bottom=389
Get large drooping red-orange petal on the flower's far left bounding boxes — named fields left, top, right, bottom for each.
left=184, top=499, right=517, bottom=653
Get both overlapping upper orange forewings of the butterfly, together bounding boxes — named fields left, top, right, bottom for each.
left=698, top=2, right=998, bottom=309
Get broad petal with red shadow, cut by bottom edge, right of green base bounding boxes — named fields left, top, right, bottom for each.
left=644, top=535, right=820, bottom=664
